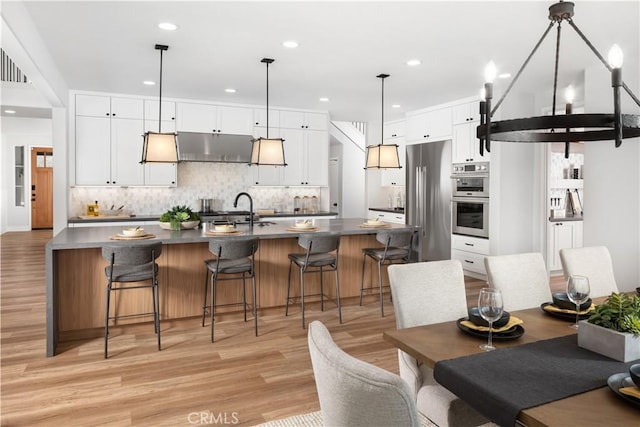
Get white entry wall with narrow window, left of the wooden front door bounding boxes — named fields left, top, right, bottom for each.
left=0, top=117, right=52, bottom=233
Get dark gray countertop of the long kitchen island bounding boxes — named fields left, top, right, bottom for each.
left=47, top=218, right=415, bottom=250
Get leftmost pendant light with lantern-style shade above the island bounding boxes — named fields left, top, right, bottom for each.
left=140, top=44, right=178, bottom=163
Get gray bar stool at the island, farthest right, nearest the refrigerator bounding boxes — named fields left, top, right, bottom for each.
left=360, top=229, right=413, bottom=317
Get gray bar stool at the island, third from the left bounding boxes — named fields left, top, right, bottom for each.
left=285, top=233, right=342, bottom=329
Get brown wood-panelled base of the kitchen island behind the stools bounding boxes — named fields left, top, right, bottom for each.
left=47, top=220, right=418, bottom=356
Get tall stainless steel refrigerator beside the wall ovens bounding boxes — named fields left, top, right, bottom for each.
left=405, top=141, right=451, bottom=261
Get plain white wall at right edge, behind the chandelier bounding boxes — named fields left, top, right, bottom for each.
left=584, top=63, right=640, bottom=291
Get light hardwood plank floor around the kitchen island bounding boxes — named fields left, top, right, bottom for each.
left=0, top=230, right=562, bottom=426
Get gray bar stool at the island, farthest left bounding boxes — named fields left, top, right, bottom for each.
left=102, top=242, right=162, bottom=359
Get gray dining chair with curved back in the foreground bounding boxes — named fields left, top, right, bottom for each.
left=308, top=320, right=428, bottom=427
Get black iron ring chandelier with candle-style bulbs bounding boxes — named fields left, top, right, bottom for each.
left=476, top=0, right=640, bottom=157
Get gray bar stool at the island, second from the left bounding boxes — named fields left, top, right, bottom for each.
left=202, top=237, right=258, bottom=342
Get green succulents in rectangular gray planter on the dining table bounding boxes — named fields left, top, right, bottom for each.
left=578, top=292, right=640, bottom=362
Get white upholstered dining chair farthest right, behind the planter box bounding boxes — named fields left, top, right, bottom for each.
left=560, top=246, right=619, bottom=297
